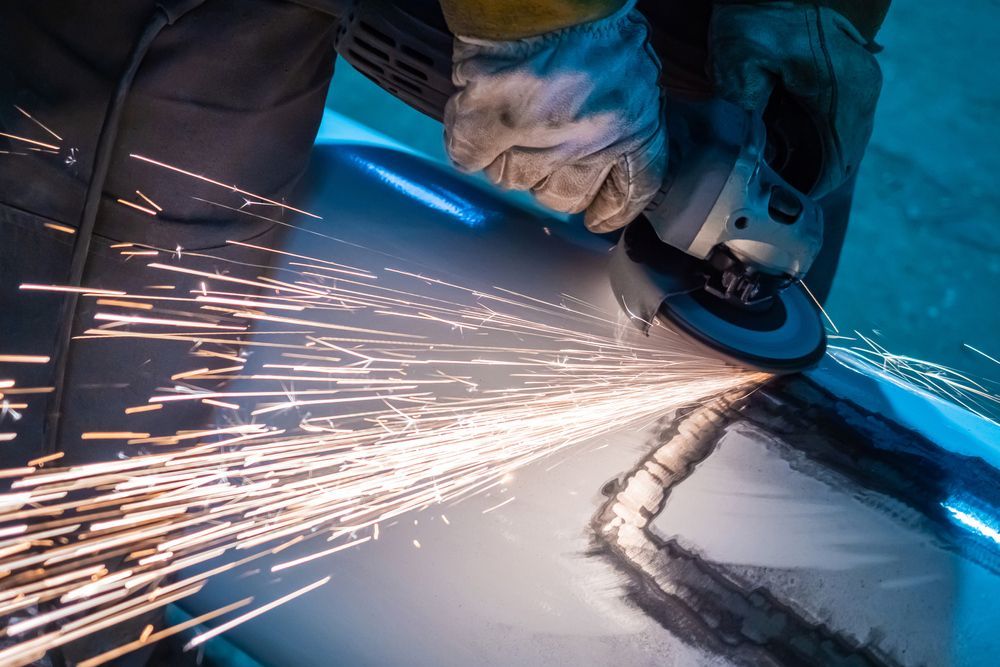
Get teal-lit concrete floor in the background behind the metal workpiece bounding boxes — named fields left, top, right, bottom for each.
left=328, top=0, right=1000, bottom=379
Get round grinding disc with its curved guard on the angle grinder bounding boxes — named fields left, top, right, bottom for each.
left=610, top=218, right=826, bottom=373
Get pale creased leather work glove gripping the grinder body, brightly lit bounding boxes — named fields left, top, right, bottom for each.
left=444, top=3, right=667, bottom=232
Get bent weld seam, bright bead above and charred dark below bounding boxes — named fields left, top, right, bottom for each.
left=592, top=391, right=897, bottom=665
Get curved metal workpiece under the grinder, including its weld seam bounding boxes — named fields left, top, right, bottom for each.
left=176, top=142, right=1000, bottom=665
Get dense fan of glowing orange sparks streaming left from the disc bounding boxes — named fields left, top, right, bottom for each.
left=0, top=237, right=768, bottom=664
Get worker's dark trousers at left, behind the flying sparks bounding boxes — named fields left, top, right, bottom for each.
left=0, top=0, right=336, bottom=665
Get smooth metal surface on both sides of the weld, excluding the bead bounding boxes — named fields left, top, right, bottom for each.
left=185, top=138, right=1000, bottom=665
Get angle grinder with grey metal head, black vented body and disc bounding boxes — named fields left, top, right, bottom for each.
left=336, top=0, right=826, bottom=373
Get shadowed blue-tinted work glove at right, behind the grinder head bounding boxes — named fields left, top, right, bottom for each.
left=709, top=2, right=882, bottom=197
